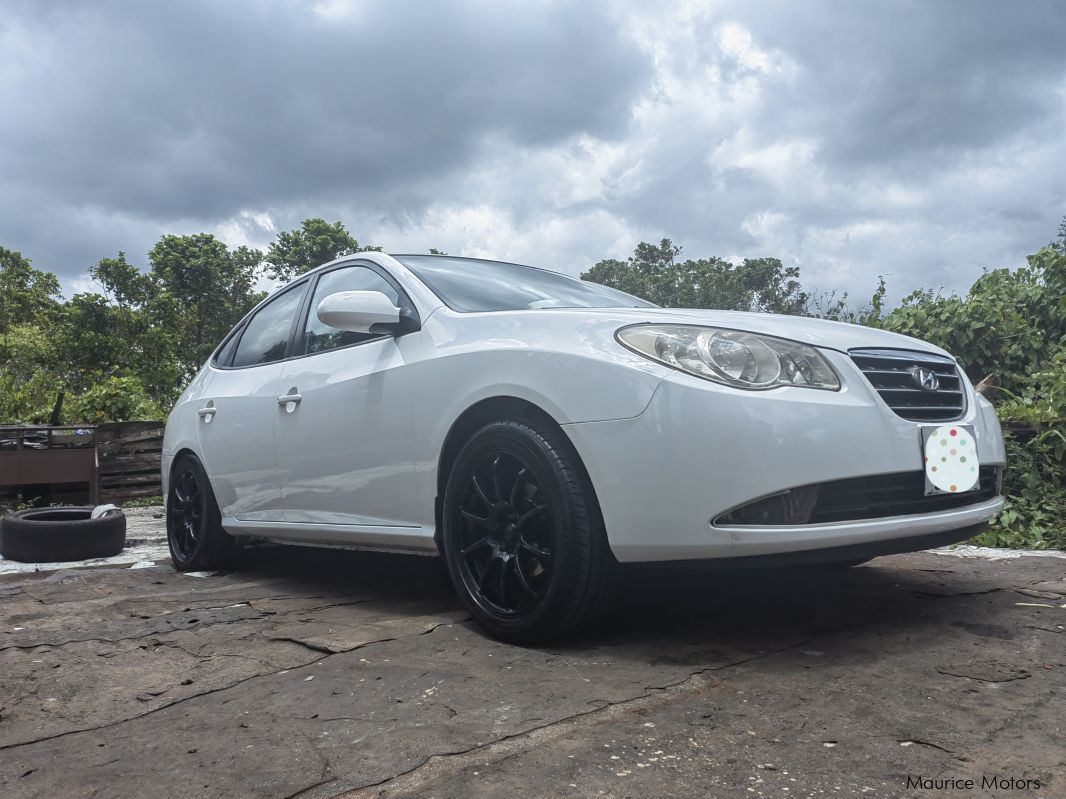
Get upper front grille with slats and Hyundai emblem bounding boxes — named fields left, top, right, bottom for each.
left=849, top=349, right=966, bottom=422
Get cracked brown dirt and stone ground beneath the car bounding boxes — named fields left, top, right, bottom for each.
left=0, top=511, right=1066, bottom=799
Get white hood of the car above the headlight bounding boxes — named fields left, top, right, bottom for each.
left=558, top=308, right=951, bottom=357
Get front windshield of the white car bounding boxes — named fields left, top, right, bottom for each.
left=393, top=256, right=655, bottom=312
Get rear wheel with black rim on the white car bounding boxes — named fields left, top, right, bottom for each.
left=166, top=454, right=240, bottom=571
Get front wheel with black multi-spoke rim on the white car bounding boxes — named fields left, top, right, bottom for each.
left=442, top=421, right=620, bottom=643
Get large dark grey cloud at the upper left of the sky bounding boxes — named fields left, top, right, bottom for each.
left=0, top=1, right=648, bottom=279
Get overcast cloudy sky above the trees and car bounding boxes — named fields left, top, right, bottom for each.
left=0, top=0, right=1066, bottom=297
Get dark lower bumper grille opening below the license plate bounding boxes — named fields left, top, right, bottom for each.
left=714, top=466, right=1000, bottom=525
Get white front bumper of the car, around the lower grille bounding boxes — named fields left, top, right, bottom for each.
left=564, top=350, right=1005, bottom=561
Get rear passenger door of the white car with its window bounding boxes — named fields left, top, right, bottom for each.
left=197, top=280, right=309, bottom=521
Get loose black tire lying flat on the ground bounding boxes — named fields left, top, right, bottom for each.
left=0, top=506, right=126, bottom=564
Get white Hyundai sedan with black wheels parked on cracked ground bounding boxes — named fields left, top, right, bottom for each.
left=163, top=252, right=1004, bottom=641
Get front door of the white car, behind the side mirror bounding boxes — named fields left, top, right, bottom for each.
left=277, top=263, right=421, bottom=534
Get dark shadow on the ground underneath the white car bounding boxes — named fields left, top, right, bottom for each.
left=231, top=547, right=988, bottom=665
